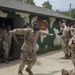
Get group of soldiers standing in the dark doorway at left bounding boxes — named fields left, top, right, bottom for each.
left=0, top=22, right=12, bottom=63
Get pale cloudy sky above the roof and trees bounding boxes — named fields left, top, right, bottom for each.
left=34, top=0, right=75, bottom=11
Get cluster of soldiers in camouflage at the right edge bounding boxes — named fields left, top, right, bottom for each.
left=59, top=23, right=75, bottom=75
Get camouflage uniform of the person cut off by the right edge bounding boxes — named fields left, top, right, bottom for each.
left=69, top=34, right=75, bottom=67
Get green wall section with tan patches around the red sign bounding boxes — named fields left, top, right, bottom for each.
left=29, top=15, right=62, bottom=49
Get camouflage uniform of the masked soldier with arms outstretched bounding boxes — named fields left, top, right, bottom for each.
left=11, top=28, right=53, bottom=75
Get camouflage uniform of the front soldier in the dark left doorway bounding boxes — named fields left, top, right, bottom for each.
left=2, top=29, right=12, bottom=62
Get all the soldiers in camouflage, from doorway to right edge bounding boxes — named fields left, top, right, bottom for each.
left=0, top=21, right=75, bottom=75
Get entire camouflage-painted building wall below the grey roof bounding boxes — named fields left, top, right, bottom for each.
left=0, top=11, right=73, bottom=58
